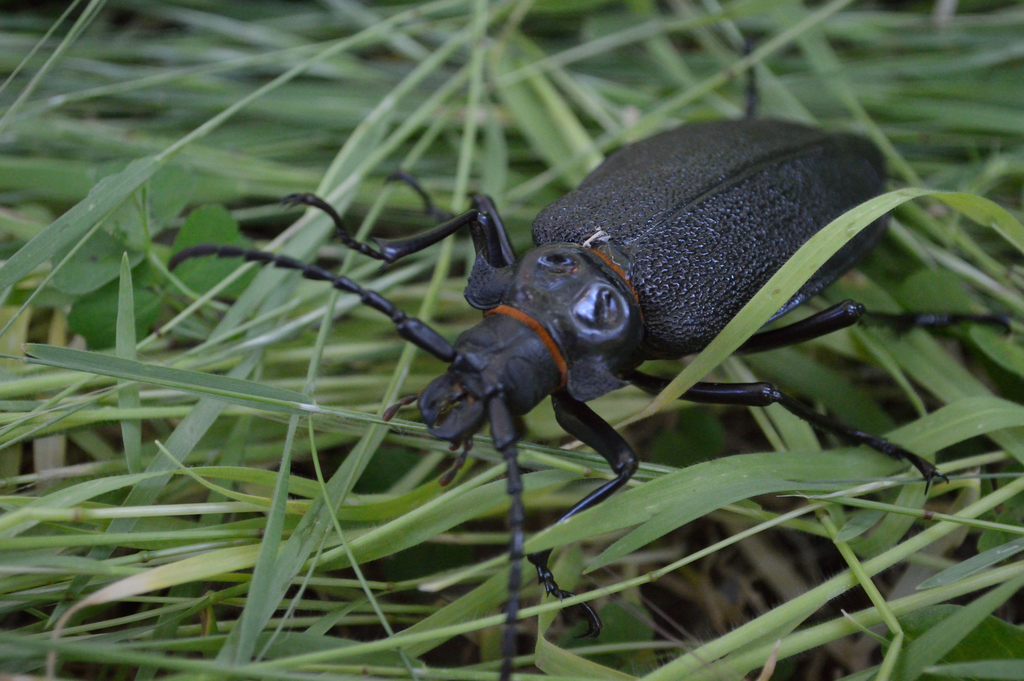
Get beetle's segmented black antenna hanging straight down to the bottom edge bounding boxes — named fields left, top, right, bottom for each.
left=487, top=392, right=525, bottom=681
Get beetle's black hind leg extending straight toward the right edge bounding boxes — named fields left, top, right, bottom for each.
left=737, top=300, right=1011, bottom=352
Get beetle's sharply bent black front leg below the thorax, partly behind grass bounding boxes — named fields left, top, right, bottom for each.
left=527, top=390, right=638, bottom=638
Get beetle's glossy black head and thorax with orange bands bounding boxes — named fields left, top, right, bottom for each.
left=420, top=244, right=643, bottom=443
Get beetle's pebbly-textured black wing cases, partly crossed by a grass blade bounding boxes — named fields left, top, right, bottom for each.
left=534, top=120, right=886, bottom=358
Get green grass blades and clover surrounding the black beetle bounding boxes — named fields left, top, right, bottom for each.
left=0, top=0, right=1024, bottom=680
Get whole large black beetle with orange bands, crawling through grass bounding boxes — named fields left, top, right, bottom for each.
left=171, top=119, right=1008, bottom=679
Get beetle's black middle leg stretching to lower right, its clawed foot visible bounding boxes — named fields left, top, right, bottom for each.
left=627, top=371, right=949, bottom=485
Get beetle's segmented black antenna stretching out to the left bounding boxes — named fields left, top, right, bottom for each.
left=167, top=242, right=456, bottom=361
